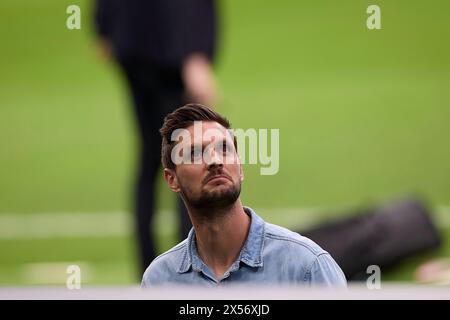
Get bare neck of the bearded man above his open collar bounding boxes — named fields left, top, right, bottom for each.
left=191, top=199, right=251, bottom=279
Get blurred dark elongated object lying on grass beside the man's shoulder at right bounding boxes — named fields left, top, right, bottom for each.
left=299, top=197, right=442, bottom=281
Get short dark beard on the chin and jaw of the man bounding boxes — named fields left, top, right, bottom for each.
left=180, top=182, right=241, bottom=217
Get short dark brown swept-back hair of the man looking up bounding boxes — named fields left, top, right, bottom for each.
left=159, top=103, right=237, bottom=169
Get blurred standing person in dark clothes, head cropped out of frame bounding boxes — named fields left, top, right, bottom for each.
left=95, top=0, right=217, bottom=272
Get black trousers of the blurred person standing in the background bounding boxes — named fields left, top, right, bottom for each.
left=120, top=59, right=192, bottom=276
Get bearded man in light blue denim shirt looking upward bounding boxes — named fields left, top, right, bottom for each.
left=142, top=104, right=346, bottom=288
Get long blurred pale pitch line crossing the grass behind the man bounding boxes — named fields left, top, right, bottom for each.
left=0, top=206, right=450, bottom=240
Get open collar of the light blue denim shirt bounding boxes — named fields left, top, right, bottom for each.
left=178, top=207, right=265, bottom=273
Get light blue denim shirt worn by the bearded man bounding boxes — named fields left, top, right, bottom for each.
left=141, top=207, right=347, bottom=288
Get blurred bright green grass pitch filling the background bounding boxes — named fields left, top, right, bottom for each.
left=0, top=0, right=450, bottom=285
